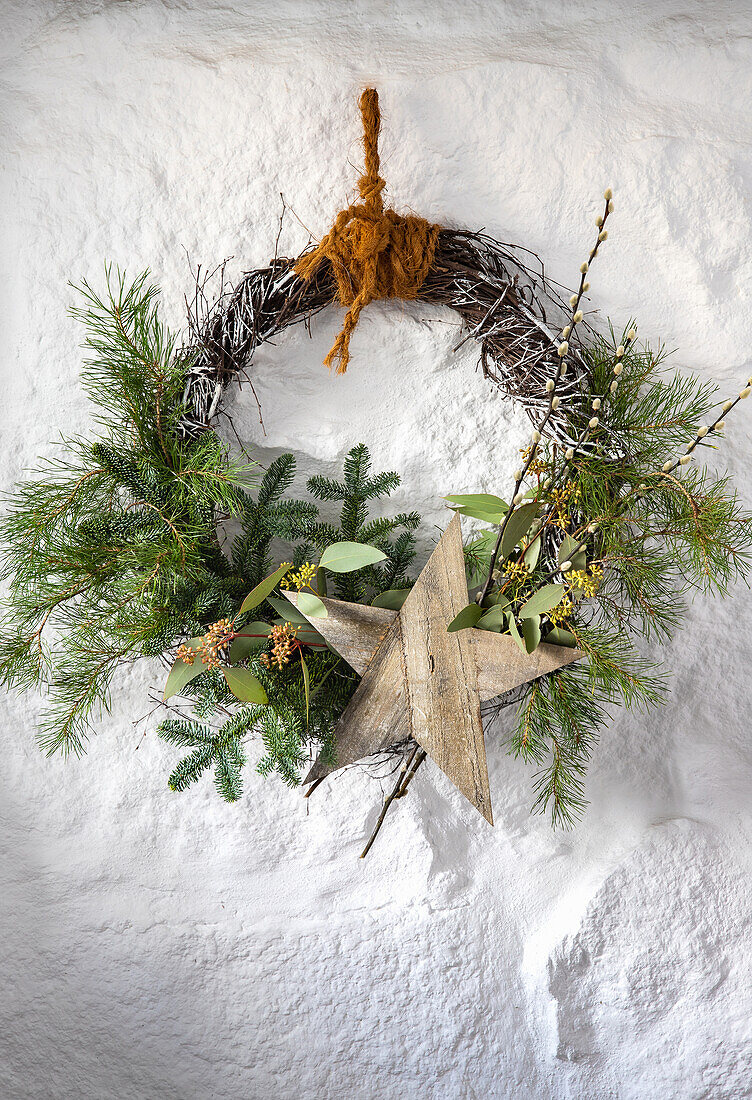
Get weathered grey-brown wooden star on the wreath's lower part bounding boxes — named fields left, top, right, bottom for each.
left=285, top=516, right=585, bottom=824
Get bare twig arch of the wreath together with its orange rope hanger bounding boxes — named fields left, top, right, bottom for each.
left=183, top=88, right=580, bottom=441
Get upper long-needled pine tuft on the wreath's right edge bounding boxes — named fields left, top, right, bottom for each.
left=572, top=342, right=752, bottom=641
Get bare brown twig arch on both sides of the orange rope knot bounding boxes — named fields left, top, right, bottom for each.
left=181, top=229, right=584, bottom=443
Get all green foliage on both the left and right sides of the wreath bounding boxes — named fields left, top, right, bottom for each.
left=10, top=267, right=752, bottom=825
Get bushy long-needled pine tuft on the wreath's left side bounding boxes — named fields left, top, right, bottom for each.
left=0, top=268, right=255, bottom=752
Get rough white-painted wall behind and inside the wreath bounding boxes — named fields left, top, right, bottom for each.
left=0, top=0, right=752, bottom=1100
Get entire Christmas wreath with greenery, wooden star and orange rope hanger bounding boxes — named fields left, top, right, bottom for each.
left=0, top=90, right=752, bottom=854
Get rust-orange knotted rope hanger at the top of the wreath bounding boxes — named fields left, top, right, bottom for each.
left=295, top=88, right=441, bottom=374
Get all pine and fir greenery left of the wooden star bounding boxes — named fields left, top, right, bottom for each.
left=0, top=275, right=418, bottom=799
